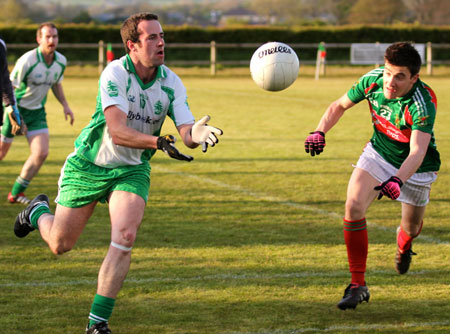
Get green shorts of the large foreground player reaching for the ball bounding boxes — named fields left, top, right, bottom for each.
left=56, top=153, right=151, bottom=208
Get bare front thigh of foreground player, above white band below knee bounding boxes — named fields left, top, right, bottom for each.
left=109, top=191, right=146, bottom=247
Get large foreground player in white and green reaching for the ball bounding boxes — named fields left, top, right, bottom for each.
left=14, top=13, right=222, bottom=334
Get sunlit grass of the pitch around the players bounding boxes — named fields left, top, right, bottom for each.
left=0, top=68, right=450, bottom=334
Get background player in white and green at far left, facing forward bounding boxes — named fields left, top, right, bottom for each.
left=0, top=22, right=74, bottom=204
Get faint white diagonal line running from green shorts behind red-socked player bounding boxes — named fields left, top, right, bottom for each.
left=152, top=166, right=450, bottom=245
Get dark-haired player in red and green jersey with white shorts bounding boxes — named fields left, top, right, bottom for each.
left=305, top=42, right=441, bottom=310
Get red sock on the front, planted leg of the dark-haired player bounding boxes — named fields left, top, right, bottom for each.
left=344, top=218, right=369, bottom=285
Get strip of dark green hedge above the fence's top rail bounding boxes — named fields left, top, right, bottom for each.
left=0, top=24, right=450, bottom=43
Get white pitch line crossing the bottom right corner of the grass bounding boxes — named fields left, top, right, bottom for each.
left=228, top=321, right=450, bottom=334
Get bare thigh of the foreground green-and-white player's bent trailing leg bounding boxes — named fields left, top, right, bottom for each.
left=50, top=202, right=97, bottom=248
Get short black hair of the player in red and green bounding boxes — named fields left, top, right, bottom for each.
left=384, top=42, right=422, bottom=76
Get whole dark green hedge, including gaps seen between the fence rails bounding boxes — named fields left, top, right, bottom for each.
left=0, top=24, right=450, bottom=61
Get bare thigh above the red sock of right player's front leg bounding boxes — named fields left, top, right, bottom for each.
left=345, top=167, right=379, bottom=220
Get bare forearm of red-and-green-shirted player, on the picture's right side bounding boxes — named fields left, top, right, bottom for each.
left=396, top=130, right=431, bottom=182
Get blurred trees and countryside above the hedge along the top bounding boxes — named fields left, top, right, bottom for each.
left=0, top=0, right=450, bottom=27
